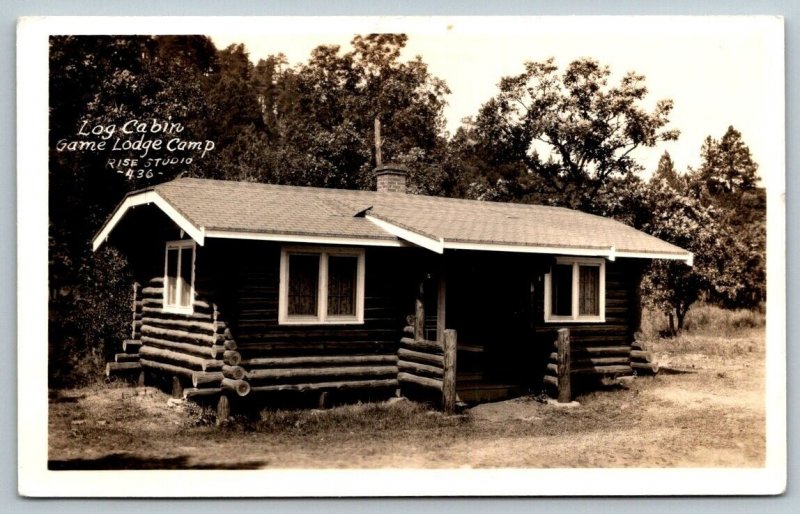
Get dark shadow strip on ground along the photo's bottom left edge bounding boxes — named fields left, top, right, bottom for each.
left=47, top=452, right=267, bottom=471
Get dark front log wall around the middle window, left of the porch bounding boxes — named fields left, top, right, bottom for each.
left=197, top=241, right=412, bottom=394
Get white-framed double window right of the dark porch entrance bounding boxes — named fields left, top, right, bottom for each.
left=544, top=257, right=606, bottom=322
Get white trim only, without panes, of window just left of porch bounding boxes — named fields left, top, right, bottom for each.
left=278, top=246, right=364, bottom=325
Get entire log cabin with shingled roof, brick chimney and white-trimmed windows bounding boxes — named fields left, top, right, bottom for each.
left=93, top=166, right=692, bottom=412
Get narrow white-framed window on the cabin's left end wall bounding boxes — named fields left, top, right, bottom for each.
left=164, top=240, right=195, bottom=314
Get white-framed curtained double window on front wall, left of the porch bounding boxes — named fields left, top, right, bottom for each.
left=278, top=248, right=364, bottom=324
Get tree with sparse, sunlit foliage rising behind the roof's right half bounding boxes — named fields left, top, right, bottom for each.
left=466, top=58, right=678, bottom=211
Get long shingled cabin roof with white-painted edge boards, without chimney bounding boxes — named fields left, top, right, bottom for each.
left=94, top=178, right=692, bottom=263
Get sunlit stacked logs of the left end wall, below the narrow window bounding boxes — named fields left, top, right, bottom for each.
left=138, top=278, right=241, bottom=398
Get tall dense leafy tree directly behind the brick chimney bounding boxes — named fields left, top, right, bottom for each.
left=264, top=34, right=449, bottom=192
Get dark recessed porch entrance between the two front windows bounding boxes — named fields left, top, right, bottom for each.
left=400, top=251, right=547, bottom=404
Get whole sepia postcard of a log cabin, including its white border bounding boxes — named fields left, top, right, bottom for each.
left=18, top=16, right=786, bottom=496
